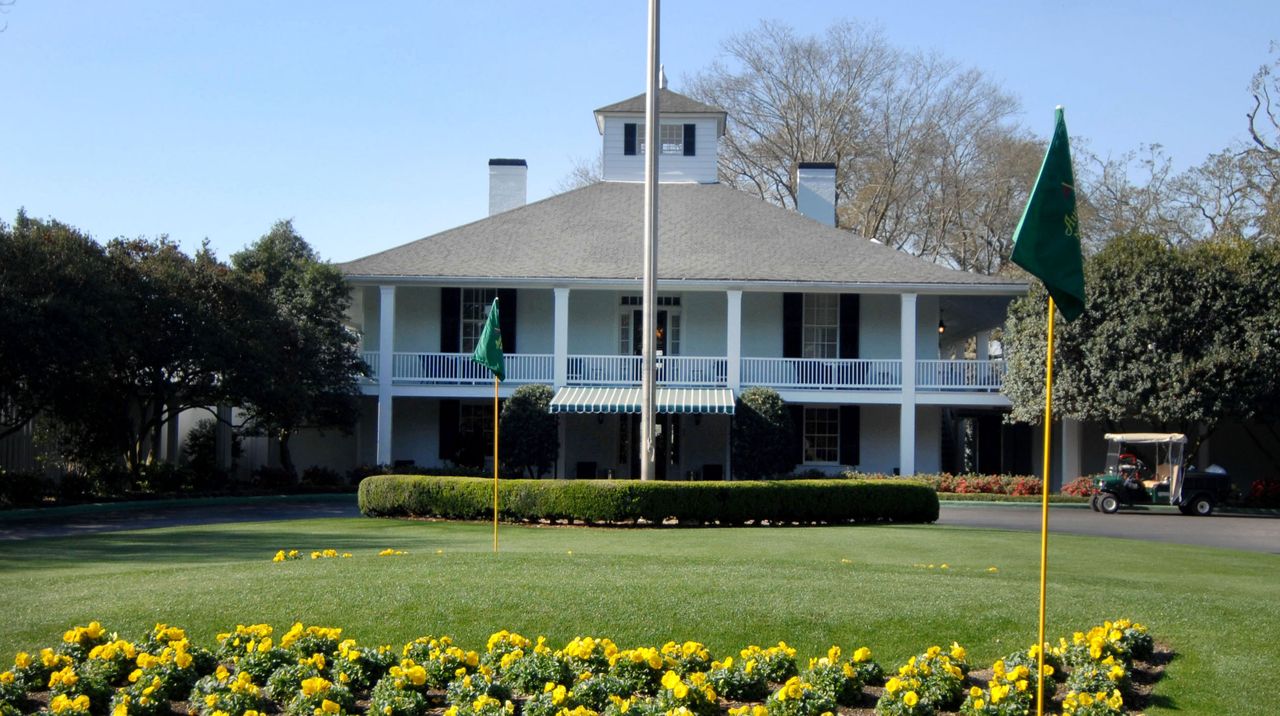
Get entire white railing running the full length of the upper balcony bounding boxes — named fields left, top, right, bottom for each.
left=362, top=351, right=1005, bottom=395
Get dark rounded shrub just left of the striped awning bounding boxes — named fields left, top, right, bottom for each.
left=499, top=383, right=559, bottom=478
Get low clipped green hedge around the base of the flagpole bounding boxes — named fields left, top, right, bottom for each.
left=360, top=475, right=938, bottom=525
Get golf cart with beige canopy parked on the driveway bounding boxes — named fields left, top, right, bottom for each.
left=1089, top=433, right=1231, bottom=515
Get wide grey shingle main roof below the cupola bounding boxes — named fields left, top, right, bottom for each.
left=338, top=182, right=1025, bottom=293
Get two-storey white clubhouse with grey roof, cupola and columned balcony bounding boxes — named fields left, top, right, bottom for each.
left=322, top=88, right=1032, bottom=479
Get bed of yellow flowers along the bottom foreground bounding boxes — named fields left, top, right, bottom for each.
left=0, top=619, right=1151, bottom=716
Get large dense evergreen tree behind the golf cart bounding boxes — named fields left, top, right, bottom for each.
left=1005, top=236, right=1280, bottom=455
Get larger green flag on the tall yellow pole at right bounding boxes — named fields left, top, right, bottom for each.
left=1010, top=108, right=1084, bottom=320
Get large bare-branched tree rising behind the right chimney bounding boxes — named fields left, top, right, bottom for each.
left=687, top=22, right=1042, bottom=273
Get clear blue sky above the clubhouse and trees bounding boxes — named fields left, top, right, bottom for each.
left=0, top=0, right=1280, bottom=261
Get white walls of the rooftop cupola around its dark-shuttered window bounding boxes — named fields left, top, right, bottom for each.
left=603, top=114, right=717, bottom=181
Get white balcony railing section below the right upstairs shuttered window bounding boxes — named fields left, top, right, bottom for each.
left=742, top=357, right=902, bottom=391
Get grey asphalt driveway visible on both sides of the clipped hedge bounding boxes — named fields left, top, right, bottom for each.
left=0, top=494, right=1280, bottom=555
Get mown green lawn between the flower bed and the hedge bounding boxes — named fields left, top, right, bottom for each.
left=0, top=519, right=1280, bottom=713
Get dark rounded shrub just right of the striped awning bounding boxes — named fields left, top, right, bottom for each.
left=730, top=386, right=796, bottom=480
